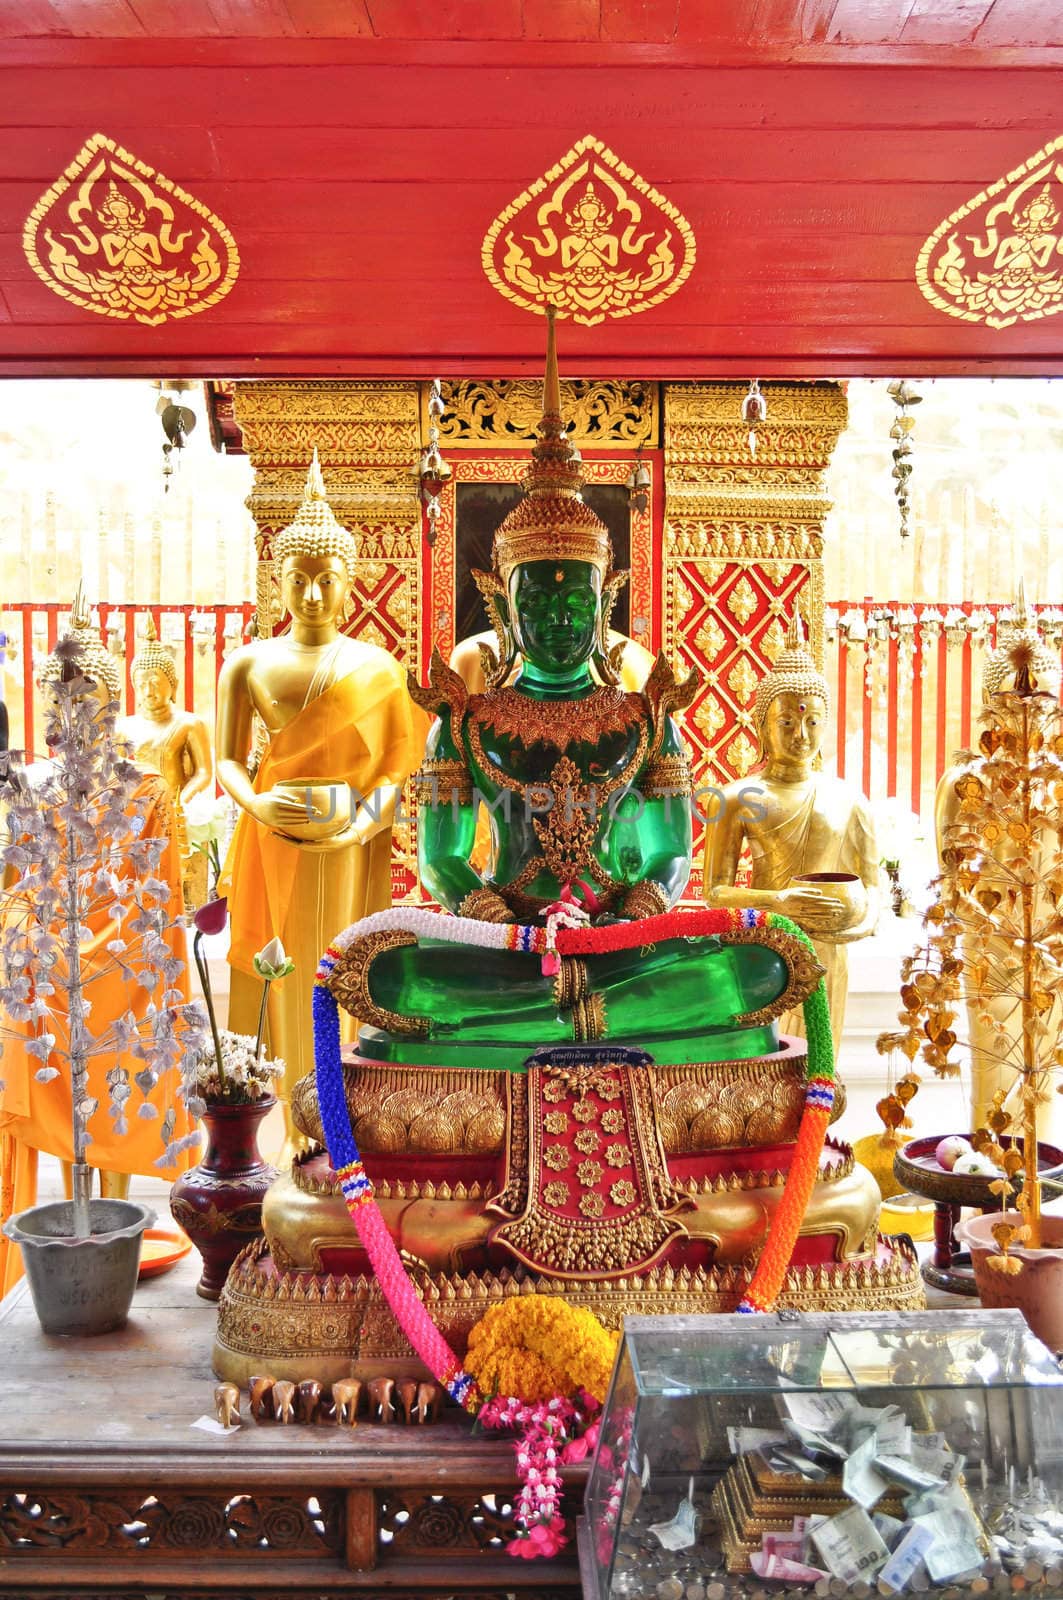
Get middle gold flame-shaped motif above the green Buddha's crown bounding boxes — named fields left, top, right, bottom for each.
left=482, top=134, right=696, bottom=326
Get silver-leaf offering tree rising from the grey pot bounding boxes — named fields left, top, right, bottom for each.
left=0, top=638, right=205, bottom=1238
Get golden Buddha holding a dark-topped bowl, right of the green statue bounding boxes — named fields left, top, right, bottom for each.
left=704, top=611, right=880, bottom=1054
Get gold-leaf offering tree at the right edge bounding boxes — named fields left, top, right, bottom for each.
left=879, top=637, right=1063, bottom=1273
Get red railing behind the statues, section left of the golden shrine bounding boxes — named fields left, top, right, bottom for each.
left=0, top=600, right=255, bottom=758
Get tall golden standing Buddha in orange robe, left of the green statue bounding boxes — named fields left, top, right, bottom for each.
left=216, top=451, right=427, bottom=1136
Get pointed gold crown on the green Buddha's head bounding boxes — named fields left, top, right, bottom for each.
left=493, top=309, right=613, bottom=584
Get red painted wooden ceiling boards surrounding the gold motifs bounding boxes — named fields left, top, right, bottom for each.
left=0, top=0, right=1063, bottom=378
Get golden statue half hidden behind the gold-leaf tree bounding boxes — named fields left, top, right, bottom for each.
left=933, top=582, right=1063, bottom=1144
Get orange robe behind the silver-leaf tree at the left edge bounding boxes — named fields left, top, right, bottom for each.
left=0, top=773, right=197, bottom=1294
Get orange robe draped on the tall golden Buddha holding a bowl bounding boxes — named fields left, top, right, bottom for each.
left=219, top=650, right=429, bottom=1098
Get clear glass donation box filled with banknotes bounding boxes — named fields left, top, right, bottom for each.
left=581, top=1310, right=1063, bottom=1600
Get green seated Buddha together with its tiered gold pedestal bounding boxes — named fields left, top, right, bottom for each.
left=215, top=324, right=922, bottom=1381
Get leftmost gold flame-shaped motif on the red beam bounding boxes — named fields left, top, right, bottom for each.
left=22, top=133, right=240, bottom=326
